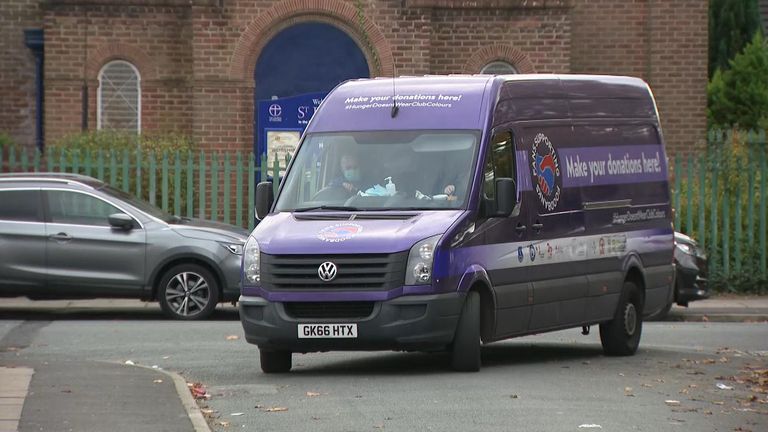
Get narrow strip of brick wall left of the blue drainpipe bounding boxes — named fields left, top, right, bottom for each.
left=0, top=0, right=42, bottom=146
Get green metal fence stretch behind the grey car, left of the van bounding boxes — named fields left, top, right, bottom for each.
left=0, top=147, right=288, bottom=233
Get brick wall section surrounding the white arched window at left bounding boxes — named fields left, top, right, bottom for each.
left=44, top=0, right=192, bottom=143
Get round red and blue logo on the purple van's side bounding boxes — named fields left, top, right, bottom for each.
left=531, top=133, right=563, bottom=212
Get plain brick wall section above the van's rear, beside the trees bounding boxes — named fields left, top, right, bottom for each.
left=571, top=0, right=708, bottom=154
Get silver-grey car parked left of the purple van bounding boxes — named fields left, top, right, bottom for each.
left=0, top=173, right=248, bottom=320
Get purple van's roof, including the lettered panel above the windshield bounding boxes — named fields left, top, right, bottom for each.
left=307, top=74, right=655, bottom=133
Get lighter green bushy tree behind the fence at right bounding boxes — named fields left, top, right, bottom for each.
left=707, top=33, right=768, bottom=129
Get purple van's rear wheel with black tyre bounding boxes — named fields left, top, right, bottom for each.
left=600, top=281, right=643, bottom=356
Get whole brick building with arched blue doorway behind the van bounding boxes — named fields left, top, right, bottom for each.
left=0, top=0, right=708, bottom=153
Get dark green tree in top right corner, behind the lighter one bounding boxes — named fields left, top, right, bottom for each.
left=709, top=0, right=762, bottom=77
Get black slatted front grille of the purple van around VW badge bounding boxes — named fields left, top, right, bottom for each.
left=261, top=251, right=408, bottom=291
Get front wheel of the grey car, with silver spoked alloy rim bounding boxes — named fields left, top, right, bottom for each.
left=157, top=264, right=219, bottom=320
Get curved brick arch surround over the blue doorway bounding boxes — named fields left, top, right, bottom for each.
left=229, top=0, right=394, bottom=81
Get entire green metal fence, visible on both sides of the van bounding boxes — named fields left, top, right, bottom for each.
left=0, top=131, right=768, bottom=290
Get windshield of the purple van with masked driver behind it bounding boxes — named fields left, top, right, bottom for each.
left=276, top=131, right=480, bottom=211
